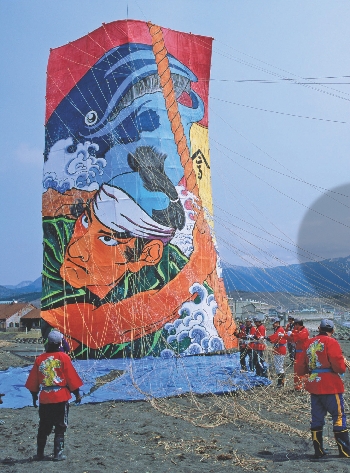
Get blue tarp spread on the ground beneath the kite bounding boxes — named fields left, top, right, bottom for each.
left=0, top=353, right=270, bottom=408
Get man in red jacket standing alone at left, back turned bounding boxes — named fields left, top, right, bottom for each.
left=25, top=330, right=83, bottom=461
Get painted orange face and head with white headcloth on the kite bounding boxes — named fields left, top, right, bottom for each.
left=60, top=185, right=175, bottom=299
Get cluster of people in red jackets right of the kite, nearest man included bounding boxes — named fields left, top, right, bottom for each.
left=236, top=316, right=350, bottom=461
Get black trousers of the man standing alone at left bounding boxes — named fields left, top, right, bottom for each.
left=38, top=401, right=69, bottom=439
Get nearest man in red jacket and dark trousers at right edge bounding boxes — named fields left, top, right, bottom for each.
left=298, top=319, right=350, bottom=459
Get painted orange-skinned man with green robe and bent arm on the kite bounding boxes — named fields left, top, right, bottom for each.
left=42, top=147, right=216, bottom=356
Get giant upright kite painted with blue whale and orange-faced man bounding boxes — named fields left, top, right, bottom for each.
left=41, top=20, right=237, bottom=359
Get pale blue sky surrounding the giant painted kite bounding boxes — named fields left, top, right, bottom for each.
left=0, top=0, right=350, bottom=285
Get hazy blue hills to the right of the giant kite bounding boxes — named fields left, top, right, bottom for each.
left=223, top=256, right=350, bottom=296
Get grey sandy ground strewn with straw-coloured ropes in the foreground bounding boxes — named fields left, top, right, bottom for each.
left=0, top=340, right=350, bottom=473
